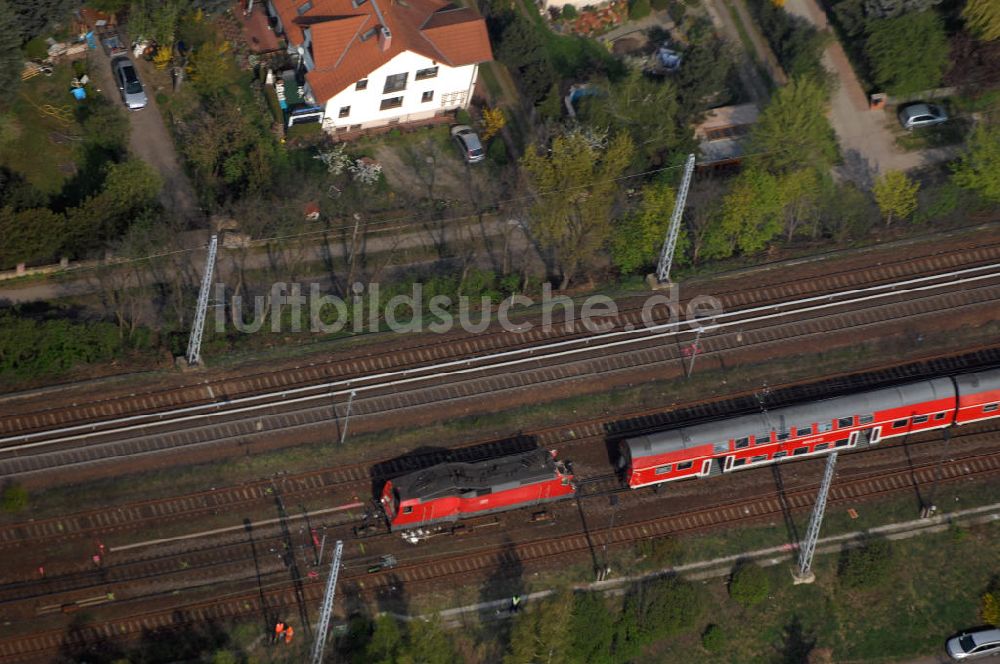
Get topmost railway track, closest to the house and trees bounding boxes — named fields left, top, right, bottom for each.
left=0, top=239, right=1000, bottom=437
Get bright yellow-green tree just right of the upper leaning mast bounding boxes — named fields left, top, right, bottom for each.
left=702, top=167, right=783, bottom=258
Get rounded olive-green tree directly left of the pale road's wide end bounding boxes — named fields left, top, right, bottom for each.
left=750, top=77, right=837, bottom=172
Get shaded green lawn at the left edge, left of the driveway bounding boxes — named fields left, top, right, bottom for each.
left=0, top=63, right=87, bottom=195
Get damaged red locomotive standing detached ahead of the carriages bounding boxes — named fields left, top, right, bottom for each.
left=381, top=449, right=576, bottom=531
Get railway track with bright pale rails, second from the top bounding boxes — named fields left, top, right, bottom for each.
left=0, top=264, right=1000, bottom=477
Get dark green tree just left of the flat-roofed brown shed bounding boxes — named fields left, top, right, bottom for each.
left=580, top=70, right=690, bottom=167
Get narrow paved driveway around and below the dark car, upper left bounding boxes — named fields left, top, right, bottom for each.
left=90, top=40, right=204, bottom=222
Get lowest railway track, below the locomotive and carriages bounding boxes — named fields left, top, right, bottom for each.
left=0, top=438, right=1000, bottom=663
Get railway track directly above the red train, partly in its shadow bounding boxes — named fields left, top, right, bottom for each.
left=0, top=346, right=1000, bottom=551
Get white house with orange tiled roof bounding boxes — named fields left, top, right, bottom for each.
left=267, top=0, right=493, bottom=134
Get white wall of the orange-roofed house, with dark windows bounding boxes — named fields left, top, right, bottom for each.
left=323, top=51, right=478, bottom=132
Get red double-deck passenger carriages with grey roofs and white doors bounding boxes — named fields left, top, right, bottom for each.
left=619, top=369, right=1000, bottom=488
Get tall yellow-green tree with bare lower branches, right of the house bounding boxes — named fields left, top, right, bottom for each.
left=521, top=131, right=634, bottom=288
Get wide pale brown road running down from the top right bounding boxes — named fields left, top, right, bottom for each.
left=785, top=0, right=955, bottom=187
